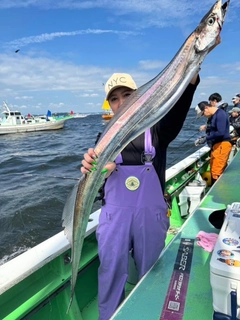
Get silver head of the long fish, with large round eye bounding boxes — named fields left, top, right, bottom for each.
left=195, top=0, right=230, bottom=52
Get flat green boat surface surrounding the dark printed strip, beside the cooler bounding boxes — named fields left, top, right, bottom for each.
left=111, top=152, right=240, bottom=320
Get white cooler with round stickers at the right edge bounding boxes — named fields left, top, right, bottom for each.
left=210, top=202, right=240, bottom=320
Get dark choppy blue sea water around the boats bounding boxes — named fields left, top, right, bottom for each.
left=0, top=109, right=204, bottom=265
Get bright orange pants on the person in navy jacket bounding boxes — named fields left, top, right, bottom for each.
left=210, top=141, right=232, bottom=180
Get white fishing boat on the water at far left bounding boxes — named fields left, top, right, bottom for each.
left=0, top=101, right=69, bottom=135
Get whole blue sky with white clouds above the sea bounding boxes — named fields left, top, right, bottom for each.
left=0, top=0, right=240, bottom=114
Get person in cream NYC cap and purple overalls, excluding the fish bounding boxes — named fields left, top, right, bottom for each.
left=81, top=38, right=220, bottom=320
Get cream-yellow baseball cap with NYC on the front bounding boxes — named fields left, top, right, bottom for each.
left=105, top=73, right=137, bottom=100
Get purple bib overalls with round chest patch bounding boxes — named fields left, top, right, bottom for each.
left=97, top=129, right=169, bottom=320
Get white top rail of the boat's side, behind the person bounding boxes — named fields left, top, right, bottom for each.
left=0, top=147, right=209, bottom=294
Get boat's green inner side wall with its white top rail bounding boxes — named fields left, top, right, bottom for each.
left=0, top=147, right=214, bottom=319
